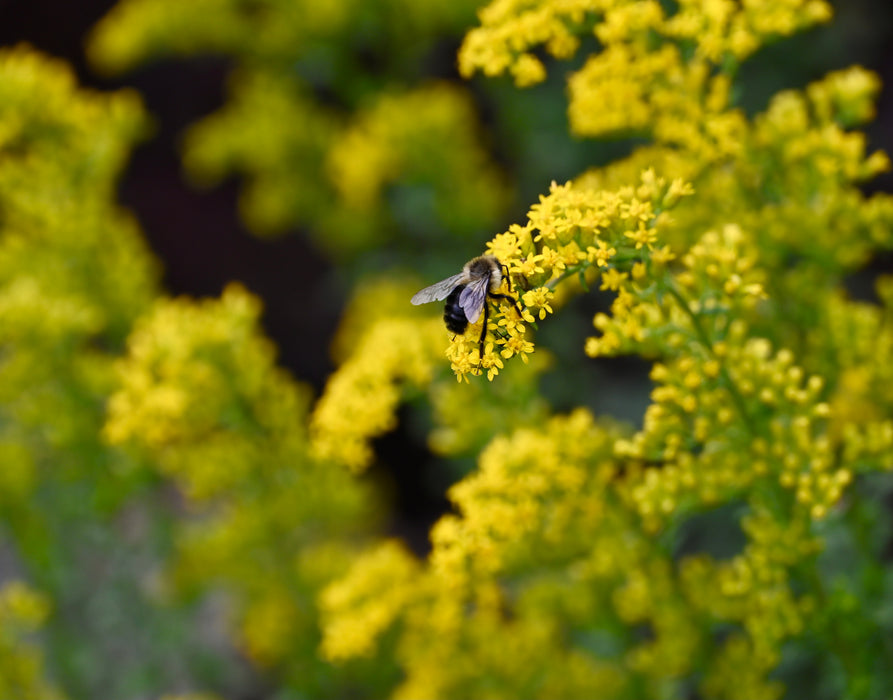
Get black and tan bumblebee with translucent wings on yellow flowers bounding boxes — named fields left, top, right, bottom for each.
left=410, top=255, right=522, bottom=357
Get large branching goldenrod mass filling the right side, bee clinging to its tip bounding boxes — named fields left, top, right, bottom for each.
left=312, top=2, right=893, bottom=698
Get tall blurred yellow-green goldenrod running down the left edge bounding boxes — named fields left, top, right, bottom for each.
left=0, top=47, right=211, bottom=697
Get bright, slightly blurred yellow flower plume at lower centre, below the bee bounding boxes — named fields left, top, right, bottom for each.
left=430, top=409, right=618, bottom=585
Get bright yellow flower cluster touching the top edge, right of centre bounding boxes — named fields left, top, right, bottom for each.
left=459, top=0, right=831, bottom=159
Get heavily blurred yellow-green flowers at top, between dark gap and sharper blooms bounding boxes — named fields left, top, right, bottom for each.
left=90, top=0, right=509, bottom=264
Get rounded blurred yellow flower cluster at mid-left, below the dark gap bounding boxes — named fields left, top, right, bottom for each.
left=105, top=285, right=308, bottom=499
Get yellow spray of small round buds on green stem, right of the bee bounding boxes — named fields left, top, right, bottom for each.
left=564, top=211, right=864, bottom=529
